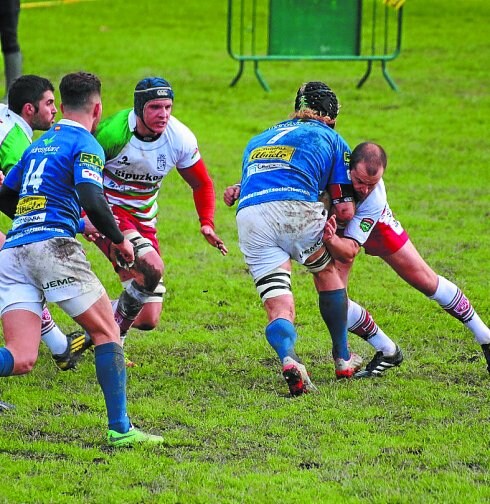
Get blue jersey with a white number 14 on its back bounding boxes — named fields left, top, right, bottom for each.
left=4, top=119, right=105, bottom=248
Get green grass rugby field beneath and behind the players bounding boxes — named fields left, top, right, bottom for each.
left=0, top=0, right=490, bottom=504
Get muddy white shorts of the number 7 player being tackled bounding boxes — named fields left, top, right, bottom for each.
left=236, top=201, right=327, bottom=280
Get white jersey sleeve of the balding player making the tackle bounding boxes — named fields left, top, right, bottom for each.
left=344, top=179, right=387, bottom=245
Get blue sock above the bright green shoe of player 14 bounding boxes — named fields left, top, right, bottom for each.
left=95, top=343, right=130, bottom=433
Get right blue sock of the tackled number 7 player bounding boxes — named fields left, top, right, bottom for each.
left=319, top=289, right=350, bottom=360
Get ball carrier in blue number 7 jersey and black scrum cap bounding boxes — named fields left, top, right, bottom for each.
left=224, top=82, right=362, bottom=396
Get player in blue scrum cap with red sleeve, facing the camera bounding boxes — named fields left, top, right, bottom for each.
left=86, top=77, right=228, bottom=356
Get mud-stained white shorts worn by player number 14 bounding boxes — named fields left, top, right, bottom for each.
left=0, top=238, right=105, bottom=317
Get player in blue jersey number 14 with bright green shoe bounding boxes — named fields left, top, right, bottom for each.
left=0, top=72, right=163, bottom=446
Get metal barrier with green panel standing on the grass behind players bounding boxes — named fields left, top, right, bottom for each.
left=227, top=0, right=403, bottom=91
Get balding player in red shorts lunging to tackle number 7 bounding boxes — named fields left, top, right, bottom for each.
left=324, top=143, right=490, bottom=378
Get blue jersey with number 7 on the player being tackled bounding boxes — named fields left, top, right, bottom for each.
left=237, top=119, right=351, bottom=212
